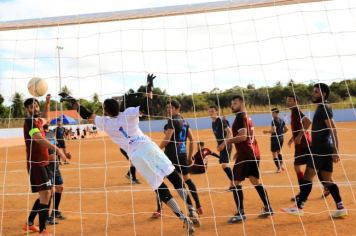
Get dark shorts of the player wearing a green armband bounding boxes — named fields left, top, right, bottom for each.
left=28, top=166, right=52, bottom=193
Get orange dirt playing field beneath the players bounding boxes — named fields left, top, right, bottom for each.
left=0, top=123, right=356, bottom=236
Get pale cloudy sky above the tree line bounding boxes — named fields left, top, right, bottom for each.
left=0, top=0, right=356, bottom=103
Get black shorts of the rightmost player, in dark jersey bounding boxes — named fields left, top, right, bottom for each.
left=307, top=146, right=334, bottom=172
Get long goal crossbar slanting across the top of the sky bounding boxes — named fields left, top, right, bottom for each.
left=0, top=0, right=329, bottom=31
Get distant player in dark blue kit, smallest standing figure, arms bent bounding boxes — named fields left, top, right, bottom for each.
left=263, top=108, right=288, bottom=173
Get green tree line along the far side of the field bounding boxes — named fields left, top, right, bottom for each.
left=0, top=79, right=356, bottom=123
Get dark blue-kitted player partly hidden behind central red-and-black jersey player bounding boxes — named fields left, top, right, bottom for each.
left=208, top=106, right=233, bottom=188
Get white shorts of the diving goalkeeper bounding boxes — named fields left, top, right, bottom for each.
left=128, top=142, right=175, bottom=190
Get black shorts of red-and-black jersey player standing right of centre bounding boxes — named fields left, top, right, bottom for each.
left=233, top=160, right=260, bottom=181
